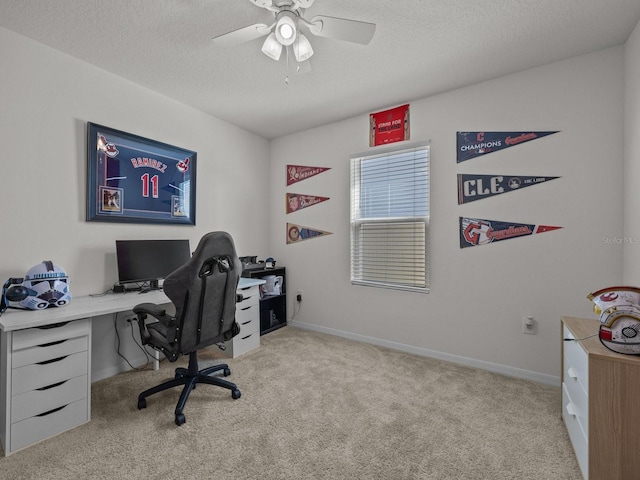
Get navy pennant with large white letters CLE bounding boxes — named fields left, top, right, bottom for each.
left=458, top=173, right=560, bottom=205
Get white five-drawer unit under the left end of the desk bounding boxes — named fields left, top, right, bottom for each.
left=0, top=319, right=91, bottom=455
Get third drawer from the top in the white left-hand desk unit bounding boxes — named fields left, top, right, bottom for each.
left=11, top=351, right=89, bottom=397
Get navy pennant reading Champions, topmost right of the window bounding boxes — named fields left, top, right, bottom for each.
left=456, top=131, right=558, bottom=163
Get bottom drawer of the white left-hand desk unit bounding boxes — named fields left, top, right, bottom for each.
left=9, top=398, right=89, bottom=452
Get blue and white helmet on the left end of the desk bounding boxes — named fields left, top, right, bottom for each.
left=19, top=260, right=71, bottom=310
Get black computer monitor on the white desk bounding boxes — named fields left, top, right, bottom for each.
left=116, top=240, right=191, bottom=289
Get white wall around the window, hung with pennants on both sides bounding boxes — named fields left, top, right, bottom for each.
left=271, top=47, right=624, bottom=383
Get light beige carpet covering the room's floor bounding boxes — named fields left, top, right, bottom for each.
left=0, top=327, right=582, bottom=480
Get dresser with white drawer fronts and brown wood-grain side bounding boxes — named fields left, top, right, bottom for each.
left=561, top=317, right=640, bottom=480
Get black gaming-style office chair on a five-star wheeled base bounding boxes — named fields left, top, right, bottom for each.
left=133, top=232, right=242, bottom=425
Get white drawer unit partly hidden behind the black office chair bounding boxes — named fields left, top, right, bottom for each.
left=225, top=285, right=260, bottom=358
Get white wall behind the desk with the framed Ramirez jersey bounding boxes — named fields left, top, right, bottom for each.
left=0, top=28, right=269, bottom=381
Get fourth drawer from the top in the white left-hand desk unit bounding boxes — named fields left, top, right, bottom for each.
left=11, top=375, right=89, bottom=423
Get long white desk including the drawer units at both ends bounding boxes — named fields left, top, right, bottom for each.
left=0, top=278, right=264, bottom=455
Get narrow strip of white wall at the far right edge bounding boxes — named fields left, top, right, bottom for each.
left=624, top=22, right=640, bottom=286
